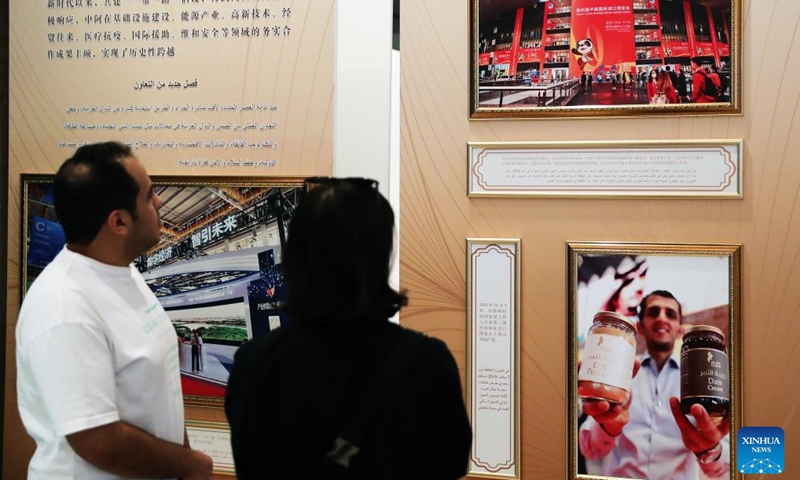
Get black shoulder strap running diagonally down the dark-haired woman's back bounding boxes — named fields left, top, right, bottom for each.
left=325, top=332, right=425, bottom=469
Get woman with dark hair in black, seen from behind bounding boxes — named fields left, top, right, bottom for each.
left=225, top=178, right=472, bottom=480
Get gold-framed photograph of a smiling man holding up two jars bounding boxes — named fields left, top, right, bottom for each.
left=567, top=243, right=742, bottom=480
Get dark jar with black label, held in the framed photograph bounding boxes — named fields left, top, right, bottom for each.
left=681, top=325, right=730, bottom=423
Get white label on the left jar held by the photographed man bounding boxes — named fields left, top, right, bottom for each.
left=578, top=333, right=636, bottom=391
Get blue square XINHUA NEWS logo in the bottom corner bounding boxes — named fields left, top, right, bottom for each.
left=736, top=427, right=786, bottom=474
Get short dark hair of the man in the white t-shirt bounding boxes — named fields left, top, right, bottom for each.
left=53, top=142, right=139, bottom=245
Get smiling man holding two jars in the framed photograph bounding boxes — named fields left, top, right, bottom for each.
left=579, top=290, right=730, bottom=480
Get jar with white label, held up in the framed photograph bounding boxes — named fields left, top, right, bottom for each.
left=578, top=312, right=636, bottom=404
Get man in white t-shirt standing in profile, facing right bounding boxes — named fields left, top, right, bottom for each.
left=16, top=142, right=212, bottom=480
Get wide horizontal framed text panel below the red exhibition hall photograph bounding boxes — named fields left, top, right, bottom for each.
left=467, top=139, right=744, bottom=199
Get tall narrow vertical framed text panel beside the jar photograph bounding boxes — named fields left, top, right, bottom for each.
left=467, top=238, right=521, bottom=478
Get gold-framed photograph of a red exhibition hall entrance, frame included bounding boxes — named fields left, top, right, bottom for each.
left=470, top=0, right=742, bottom=119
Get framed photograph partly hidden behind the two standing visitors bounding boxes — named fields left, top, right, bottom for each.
left=20, top=175, right=303, bottom=405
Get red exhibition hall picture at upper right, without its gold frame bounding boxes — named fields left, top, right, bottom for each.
left=478, top=0, right=731, bottom=107
